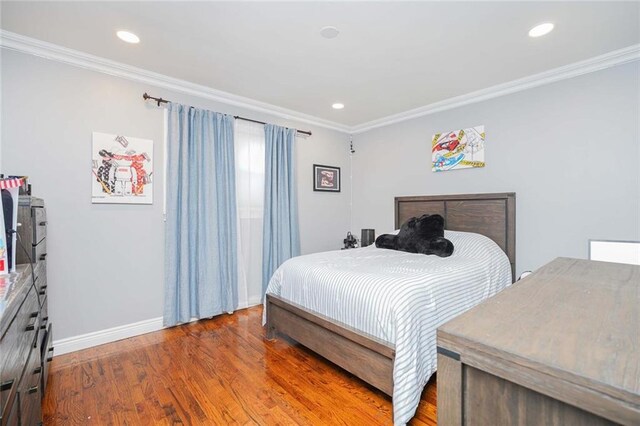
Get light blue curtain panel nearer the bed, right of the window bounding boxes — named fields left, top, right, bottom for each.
left=262, top=124, right=300, bottom=294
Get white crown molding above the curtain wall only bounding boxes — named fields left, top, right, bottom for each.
left=0, top=30, right=351, bottom=133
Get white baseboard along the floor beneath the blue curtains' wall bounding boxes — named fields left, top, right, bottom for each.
left=53, top=299, right=262, bottom=356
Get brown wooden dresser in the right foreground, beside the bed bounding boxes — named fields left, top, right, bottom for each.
left=438, top=258, right=640, bottom=426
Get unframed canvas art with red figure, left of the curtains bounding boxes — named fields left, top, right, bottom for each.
left=91, top=132, right=153, bottom=204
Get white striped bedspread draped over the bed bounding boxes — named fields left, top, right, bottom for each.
left=267, top=231, right=511, bottom=425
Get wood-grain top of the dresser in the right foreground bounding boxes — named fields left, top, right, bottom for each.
left=438, top=258, right=640, bottom=425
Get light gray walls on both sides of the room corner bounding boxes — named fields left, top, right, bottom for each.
left=0, top=49, right=640, bottom=339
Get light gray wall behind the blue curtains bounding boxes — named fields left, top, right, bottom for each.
left=0, top=49, right=349, bottom=339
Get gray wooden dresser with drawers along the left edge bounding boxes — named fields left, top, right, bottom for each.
left=0, top=197, right=53, bottom=426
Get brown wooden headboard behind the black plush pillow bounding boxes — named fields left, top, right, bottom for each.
left=395, top=192, right=516, bottom=278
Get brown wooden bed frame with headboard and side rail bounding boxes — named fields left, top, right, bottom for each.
left=266, top=192, right=516, bottom=395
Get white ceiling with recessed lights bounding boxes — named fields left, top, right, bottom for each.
left=1, top=1, right=640, bottom=126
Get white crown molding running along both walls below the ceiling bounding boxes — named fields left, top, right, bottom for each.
left=0, top=30, right=640, bottom=134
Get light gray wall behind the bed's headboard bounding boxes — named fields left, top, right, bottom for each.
left=353, top=62, right=640, bottom=272
